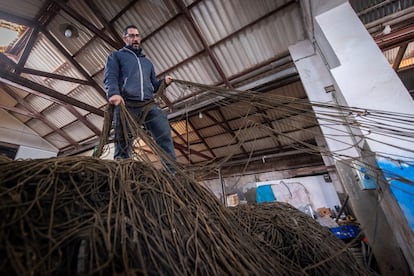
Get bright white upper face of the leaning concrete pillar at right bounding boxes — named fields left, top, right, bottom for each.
left=315, top=2, right=414, bottom=160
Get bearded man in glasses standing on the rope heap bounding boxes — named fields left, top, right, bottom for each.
left=104, top=25, right=176, bottom=172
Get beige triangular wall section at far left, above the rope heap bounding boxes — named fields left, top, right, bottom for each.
left=0, top=110, right=58, bottom=159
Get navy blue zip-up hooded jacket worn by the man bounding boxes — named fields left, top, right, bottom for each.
left=104, top=46, right=161, bottom=101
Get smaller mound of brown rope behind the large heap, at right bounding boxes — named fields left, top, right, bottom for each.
left=230, top=202, right=363, bottom=275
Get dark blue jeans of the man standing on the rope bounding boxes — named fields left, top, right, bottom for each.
left=114, top=104, right=176, bottom=172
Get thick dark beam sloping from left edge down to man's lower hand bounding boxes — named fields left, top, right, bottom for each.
left=0, top=68, right=104, bottom=117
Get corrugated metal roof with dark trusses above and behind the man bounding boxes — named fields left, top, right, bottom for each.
left=0, top=0, right=414, bottom=170
